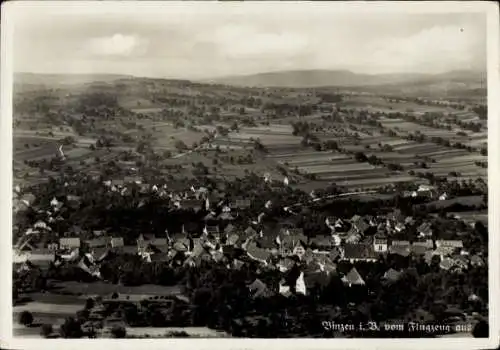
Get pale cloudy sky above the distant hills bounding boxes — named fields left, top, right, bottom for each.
left=13, top=4, right=486, bottom=79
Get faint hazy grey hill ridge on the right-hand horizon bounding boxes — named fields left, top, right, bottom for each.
left=204, top=70, right=486, bottom=88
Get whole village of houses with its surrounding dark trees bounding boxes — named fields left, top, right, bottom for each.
left=13, top=172, right=487, bottom=336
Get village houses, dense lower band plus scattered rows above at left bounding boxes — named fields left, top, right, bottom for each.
left=14, top=181, right=484, bottom=300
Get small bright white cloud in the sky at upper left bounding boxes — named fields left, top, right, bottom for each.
left=86, top=34, right=147, bottom=56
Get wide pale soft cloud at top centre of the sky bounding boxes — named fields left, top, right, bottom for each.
left=208, top=25, right=309, bottom=59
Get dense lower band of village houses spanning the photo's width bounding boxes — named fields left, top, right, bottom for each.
left=14, top=205, right=485, bottom=295
